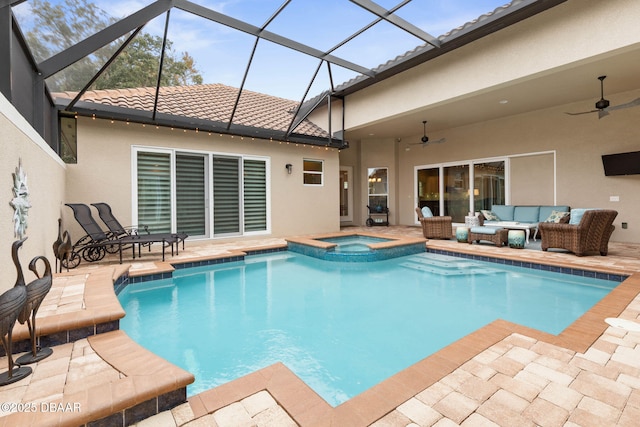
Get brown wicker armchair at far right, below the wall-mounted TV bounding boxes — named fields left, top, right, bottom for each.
left=538, top=209, right=618, bottom=256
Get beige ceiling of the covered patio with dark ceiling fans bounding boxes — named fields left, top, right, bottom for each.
left=347, top=46, right=640, bottom=140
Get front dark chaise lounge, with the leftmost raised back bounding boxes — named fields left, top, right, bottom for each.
left=65, top=203, right=178, bottom=268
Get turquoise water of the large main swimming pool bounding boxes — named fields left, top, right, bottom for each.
left=119, top=252, right=618, bottom=406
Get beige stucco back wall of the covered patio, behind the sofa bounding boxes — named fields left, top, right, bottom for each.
left=343, top=90, right=640, bottom=242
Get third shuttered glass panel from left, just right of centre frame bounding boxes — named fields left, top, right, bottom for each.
left=213, top=156, right=240, bottom=236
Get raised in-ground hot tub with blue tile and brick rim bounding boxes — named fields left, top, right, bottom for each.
left=287, top=233, right=426, bottom=262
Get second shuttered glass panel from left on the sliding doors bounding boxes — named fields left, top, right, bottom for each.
left=176, top=153, right=207, bottom=236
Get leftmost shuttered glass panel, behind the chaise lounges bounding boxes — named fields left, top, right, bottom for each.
left=137, top=151, right=171, bottom=233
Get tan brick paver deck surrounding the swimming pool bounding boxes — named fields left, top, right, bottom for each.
left=0, top=227, right=640, bottom=427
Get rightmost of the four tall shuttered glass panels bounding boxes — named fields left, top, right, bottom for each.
left=243, top=160, right=267, bottom=231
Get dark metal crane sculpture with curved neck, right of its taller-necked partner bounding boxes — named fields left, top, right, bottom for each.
left=16, top=255, right=53, bottom=365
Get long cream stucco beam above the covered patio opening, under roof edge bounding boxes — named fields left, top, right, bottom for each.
left=344, top=0, right=640, bottom=130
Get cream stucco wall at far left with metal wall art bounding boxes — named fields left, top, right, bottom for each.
left=0, top=94, right=65, bottom=292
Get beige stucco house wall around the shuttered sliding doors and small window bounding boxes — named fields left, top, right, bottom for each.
left=65, top=118, right=340, bottom=239
